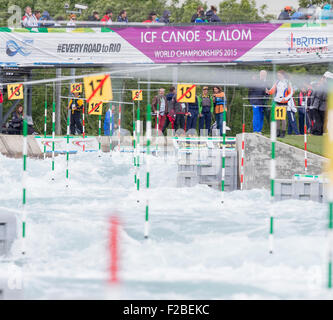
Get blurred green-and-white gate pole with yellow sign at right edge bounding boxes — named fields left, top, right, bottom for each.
left=325, top=80, right=333, bottom=289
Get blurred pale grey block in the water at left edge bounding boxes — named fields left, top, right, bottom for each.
left=0, top=210, right=17, bottom=256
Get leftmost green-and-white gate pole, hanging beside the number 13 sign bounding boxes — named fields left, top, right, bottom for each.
left=22, top=82, right=28, bottom=255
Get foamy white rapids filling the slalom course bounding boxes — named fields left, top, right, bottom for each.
left=0, top=153, right=331, bottom=299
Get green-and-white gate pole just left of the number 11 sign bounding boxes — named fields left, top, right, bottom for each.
left=269, top=101, right=276, bottom=253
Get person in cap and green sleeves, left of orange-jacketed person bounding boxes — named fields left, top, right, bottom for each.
left=198, top=87, right=214, bottom=135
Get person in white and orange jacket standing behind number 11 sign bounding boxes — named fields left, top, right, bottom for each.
left=266, top=70, right=294, bottom=138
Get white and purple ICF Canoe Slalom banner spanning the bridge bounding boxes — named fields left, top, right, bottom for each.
left=0, top=23, right=333, bottom=66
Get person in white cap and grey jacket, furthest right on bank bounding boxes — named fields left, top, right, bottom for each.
left=312, top=71, right=333, bottom=136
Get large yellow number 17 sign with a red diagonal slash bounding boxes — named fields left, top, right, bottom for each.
left=83, top=74, right=113, bottom=103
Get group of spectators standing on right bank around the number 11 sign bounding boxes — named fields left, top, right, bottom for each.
left=248, top=70, right=333, bottom=138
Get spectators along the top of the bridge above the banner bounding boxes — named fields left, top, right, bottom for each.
left=22, top=3, right=333, bottom=28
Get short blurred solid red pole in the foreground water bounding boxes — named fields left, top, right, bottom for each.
left=109, top=217, right=119, bottom=284
